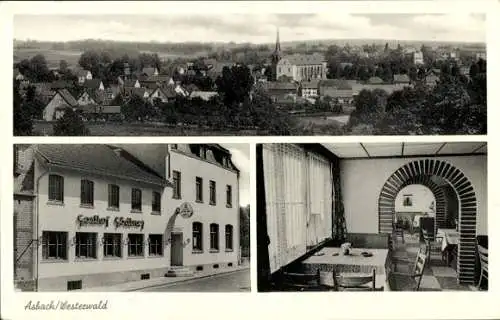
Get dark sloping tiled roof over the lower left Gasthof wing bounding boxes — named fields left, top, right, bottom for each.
left=37, top=144, right=167, bottom=186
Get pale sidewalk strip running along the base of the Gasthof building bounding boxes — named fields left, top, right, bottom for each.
left=78, top=263, right=250, bottom=292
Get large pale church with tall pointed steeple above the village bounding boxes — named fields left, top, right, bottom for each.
left=271, top=30, right=327, bottom=82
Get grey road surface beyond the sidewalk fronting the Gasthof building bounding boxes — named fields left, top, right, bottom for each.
left=141, top=269, right=251, bottom=292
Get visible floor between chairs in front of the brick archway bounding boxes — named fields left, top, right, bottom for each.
left=389, top=233, right=477, bottom=291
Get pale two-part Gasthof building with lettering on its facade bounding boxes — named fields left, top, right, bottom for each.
left=14, top=144, right=240, bottom=291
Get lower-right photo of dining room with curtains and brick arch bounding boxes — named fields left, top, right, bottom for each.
left=257, top=142, right=488, bottom=291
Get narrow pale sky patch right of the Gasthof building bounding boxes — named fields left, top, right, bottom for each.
left=220, top=143, right=250, bottom=206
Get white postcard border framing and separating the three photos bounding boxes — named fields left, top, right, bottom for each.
left=0, top=0, right=500, bottom=319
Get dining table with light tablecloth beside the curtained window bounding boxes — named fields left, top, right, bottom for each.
left=302, top=247, right=390, bottom=291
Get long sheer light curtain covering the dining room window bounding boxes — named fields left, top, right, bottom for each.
left=262, top=144, right=334, bottom=272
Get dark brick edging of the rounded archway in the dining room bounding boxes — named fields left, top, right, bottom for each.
left=379, top=159, right=477, bottom=284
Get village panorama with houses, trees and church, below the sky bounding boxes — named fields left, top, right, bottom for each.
left=13, top=28, right=487, bottom=136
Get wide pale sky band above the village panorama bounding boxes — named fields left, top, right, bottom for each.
left=14, top=12, right=486, bottom=43
